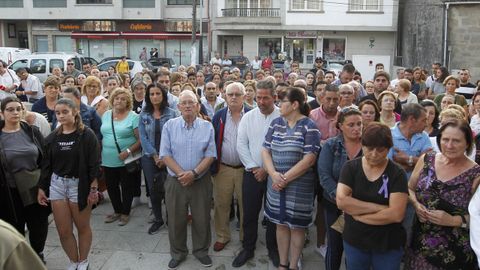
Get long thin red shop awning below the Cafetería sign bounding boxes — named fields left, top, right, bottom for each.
left=71, top=32, right=200, bottom=40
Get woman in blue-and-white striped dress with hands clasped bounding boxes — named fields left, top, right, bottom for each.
left=262, top=87, right=320, bottom=269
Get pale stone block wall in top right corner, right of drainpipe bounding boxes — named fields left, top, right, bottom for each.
left=448, top=4, right=480, bottom=82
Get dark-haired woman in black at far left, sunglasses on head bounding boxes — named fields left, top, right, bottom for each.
left=0, top=97, right=50, bottom=261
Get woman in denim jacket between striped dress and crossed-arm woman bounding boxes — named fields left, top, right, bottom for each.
left=317, top=108, right=363, bottom=270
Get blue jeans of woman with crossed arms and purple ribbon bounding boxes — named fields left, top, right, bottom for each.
left=343, top=241, right=403, bottom=270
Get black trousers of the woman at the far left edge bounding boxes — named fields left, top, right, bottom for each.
left=0, top=187, right=51, bottom=254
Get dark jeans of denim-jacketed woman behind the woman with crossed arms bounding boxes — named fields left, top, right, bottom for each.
left=322, top=199, right=343, bottom=270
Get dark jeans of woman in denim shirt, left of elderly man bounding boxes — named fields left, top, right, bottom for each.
left=141, top=156, right=167, bottom=222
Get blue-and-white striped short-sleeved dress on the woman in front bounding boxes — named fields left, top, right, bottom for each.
left=263, top=117, right=320, bottom=228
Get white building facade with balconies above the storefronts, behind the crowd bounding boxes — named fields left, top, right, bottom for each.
left=211, top=0, right=398, bottom=76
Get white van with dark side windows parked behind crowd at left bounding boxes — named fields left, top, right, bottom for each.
left=8, top=52, right=85, bottom=82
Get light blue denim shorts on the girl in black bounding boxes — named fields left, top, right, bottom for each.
left=50, top=173, right=79, bottom=203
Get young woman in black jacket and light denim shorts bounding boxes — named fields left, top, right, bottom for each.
left=38, top=98, right=100, bottom=270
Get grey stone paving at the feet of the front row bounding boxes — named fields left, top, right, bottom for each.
left=45, top=190, right=342, bottom=270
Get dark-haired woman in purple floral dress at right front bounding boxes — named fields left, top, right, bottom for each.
left=405, top=120, right=480, bottom=270
